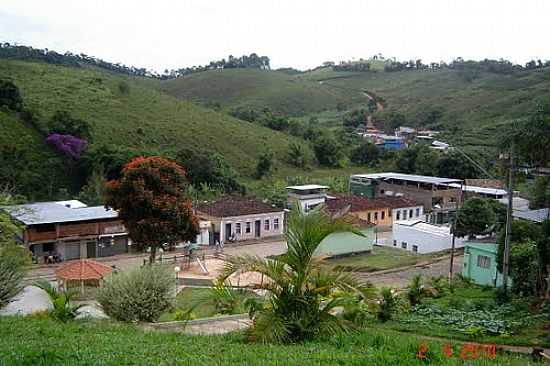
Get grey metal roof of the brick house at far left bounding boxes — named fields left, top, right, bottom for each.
left=3, top=201, right=118, bottom=225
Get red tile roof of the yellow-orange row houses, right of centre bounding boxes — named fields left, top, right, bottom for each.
left=327, top=195, right=419, bottom=212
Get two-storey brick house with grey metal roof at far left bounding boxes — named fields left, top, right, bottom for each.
left=4, top=200, right=131, bottom=262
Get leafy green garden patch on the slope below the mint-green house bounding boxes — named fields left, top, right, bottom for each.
left=369, top=287, right=550, bottom=347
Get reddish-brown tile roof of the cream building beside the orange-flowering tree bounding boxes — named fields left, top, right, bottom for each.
left=195, top=197, right=283, bottom=217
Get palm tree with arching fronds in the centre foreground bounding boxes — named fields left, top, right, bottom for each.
left=220, top=205, right=367, bottom=342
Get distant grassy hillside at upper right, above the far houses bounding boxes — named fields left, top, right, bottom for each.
left=303, top=68, right=550, bottom=145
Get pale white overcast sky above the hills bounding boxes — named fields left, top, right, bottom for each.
left=0, top=0, right=550, bottom=71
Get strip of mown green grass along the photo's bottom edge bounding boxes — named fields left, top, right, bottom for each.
left=0, top=317, right=531, bottom=366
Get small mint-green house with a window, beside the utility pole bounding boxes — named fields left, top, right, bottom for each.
left=462, top=241, right=502, bottom=287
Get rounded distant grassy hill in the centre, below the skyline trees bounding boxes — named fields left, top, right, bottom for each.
left=160, top=69, right=347, bottom=116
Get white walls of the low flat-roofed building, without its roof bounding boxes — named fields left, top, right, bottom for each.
left=386, top=224, right=464, bottom=254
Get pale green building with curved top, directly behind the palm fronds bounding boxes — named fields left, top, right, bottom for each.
left=315, top=227, right=375, bottom=257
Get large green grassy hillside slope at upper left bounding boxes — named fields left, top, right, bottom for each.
left=0, top=60, right=310, bottom=197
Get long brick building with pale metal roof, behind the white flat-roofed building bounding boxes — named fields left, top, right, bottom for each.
left=350, top=173, right=462, bottom=224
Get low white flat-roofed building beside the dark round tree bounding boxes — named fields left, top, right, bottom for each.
left=386, top=220, right=463, bottom=253
